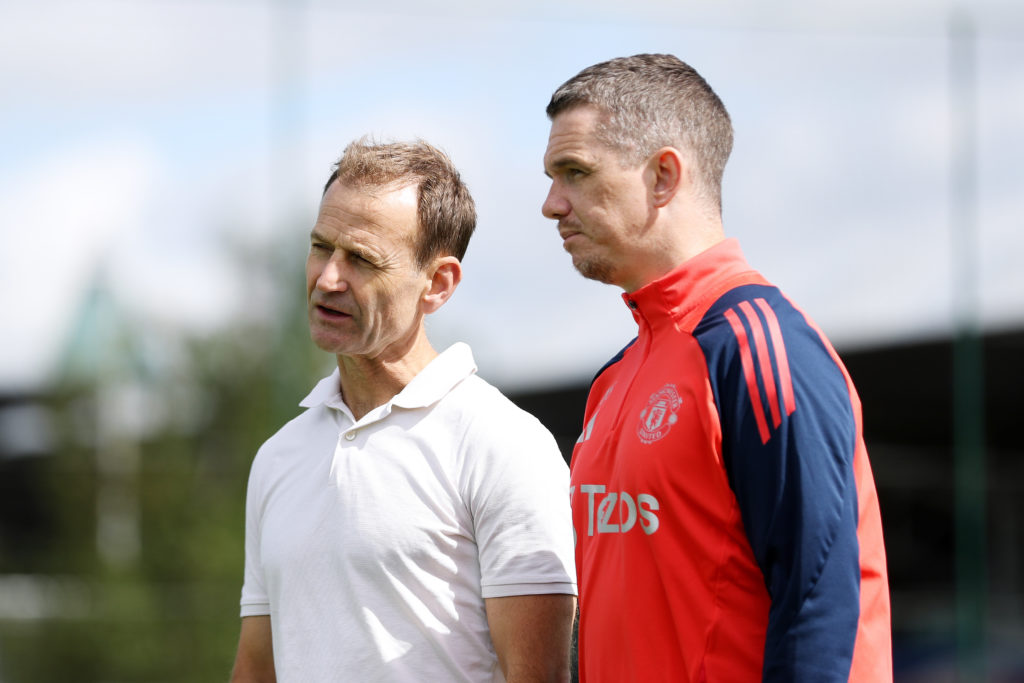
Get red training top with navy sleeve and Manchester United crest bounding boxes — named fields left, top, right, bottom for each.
left=571, top=240, right=892, bottom=683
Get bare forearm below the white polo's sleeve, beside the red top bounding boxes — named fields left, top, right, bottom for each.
left=484, top=595, right=575, bottom=683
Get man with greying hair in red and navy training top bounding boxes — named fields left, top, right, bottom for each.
left=543, top=54, right=892, bottom=683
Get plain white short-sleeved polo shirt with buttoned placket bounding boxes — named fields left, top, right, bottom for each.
left=242, top=343, right=577, bottom=683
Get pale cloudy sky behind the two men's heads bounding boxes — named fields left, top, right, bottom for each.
left=0, top=0, right=1024, bottom=390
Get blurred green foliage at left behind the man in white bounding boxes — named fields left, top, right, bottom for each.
left=0, top=231, right=331, bottom=683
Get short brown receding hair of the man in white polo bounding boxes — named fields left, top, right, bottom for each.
left=324, top=136, right=476, bottom=267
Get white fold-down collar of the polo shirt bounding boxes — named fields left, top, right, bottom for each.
left=299, top=342, right=476, bottom=412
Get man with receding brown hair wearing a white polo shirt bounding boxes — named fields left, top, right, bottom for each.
left=231, top=139, right=577, bottom=683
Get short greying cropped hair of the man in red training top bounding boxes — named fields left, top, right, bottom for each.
left=547, top=54, right=732, bottom=209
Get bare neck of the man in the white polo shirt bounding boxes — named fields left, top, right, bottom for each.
left=338, top=326, right=437, bottom=420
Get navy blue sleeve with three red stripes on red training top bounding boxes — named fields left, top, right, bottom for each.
left=694, top=285, right=860, bottom=681
